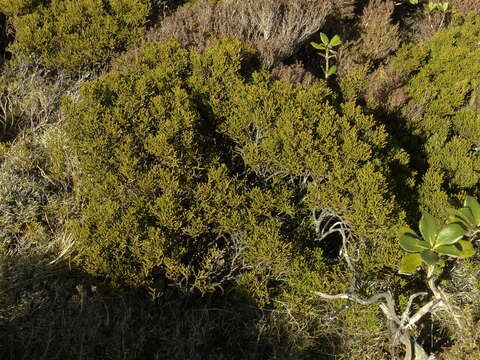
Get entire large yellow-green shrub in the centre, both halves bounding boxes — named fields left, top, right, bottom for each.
left=64, top=39, right=401, bottom=306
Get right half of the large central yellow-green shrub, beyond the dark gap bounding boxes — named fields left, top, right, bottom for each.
left=197, top=55, right=408, bottom=267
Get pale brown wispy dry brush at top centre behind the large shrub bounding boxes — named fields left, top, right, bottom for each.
left=147, top=0, right=333, bottom=67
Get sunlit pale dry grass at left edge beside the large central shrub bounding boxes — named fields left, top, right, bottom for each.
left=0, top=127, right=76, bottom=264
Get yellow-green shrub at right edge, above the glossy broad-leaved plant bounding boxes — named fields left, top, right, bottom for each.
left=393, top=14, right=480, bottom=215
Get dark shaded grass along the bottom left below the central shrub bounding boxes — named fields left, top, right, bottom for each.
left=0, top=269, right=268, bottom=360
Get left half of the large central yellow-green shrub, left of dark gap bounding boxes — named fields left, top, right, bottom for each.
left=66, top=38, right=291, bottom=291
